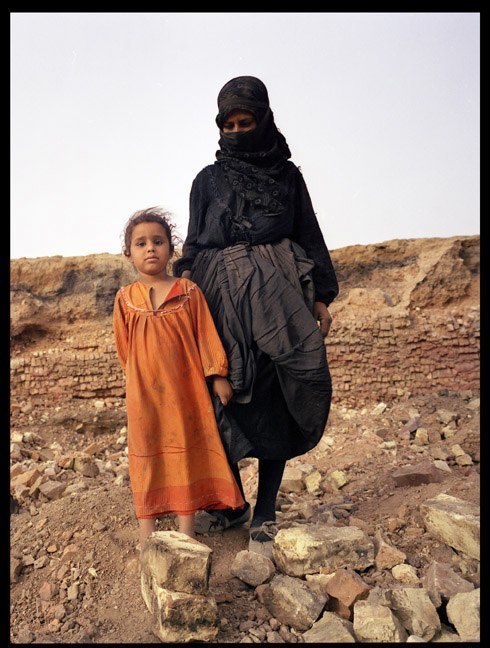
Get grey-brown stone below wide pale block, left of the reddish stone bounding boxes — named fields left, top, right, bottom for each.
left=263, top=574, right=328, bottom=630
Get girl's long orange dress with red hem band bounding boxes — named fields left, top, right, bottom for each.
left=113, top=278, right=244, bottom=518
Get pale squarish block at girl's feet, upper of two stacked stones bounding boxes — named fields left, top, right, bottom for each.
left=141, top=531, right=212, bottom=594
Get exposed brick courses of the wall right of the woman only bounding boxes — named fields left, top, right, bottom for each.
left=327, top=307, right=480, bottom=406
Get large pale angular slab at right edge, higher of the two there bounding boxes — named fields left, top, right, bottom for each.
left=420, top=493, right=480, bottom=560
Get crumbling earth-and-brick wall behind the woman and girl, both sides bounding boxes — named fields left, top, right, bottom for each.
left=11, top=236, right=480, bottom=406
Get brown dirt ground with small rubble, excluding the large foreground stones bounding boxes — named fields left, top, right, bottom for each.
left=10, top=390, right=480, bottom=644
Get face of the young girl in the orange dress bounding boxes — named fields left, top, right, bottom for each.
left=129, top=222, right=172, bottom=277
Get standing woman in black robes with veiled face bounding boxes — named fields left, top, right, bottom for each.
left=174, top=76, right=338, bottom=555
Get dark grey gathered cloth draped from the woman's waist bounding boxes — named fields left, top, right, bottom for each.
left=192, top=239, right=332, bottom=456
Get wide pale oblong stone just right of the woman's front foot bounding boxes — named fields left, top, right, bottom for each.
left=272, top=524, right=374, bottom=576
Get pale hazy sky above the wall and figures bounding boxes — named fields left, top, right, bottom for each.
left=10, top=12, right=480, bottom=258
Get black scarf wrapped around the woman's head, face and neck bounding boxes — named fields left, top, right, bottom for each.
left=216, top=76, right=291, bottom=215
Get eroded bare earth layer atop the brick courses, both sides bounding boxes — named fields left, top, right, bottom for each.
left=10, top=236, right=480, bottom=338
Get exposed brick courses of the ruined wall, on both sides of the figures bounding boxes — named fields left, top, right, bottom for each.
left=11, top=306, right=480, bottom=407
